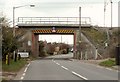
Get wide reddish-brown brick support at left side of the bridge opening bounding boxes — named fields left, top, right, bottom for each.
left=32, top=33, right=39, bottom=57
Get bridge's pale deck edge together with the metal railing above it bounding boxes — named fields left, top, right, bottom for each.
left=18, top=17, right=91, bottom=28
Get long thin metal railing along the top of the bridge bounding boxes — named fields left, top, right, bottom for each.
left=18, top=17, right=91, bottom=25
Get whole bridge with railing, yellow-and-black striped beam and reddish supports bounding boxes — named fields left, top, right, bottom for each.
left=17, top=17, right=92, bottom=56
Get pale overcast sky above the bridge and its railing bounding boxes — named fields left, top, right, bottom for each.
left=0, top=0, right=119, bottom=44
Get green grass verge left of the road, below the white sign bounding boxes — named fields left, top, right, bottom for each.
left=2, top=59, right=27, bottom=72
